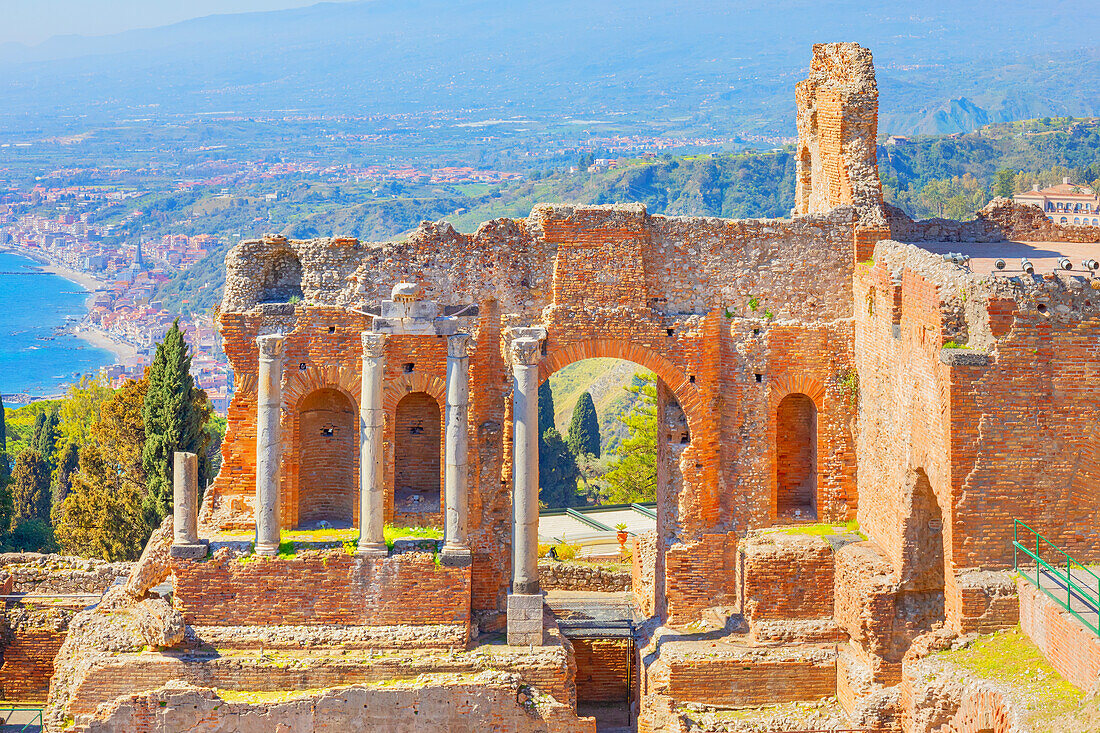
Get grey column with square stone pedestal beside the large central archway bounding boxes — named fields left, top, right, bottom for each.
left=508, top=338, right=542, bottom=646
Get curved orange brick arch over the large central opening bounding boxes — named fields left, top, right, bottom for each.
left=539, top=339, right=703, bottom=437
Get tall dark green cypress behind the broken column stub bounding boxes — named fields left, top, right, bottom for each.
left=142, top=318, right=210, bottom=527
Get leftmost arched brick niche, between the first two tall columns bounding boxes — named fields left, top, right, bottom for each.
left=298, top=389, right=359, bottom=529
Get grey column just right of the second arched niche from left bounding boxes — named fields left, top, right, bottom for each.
left=442, top=333, right=471, bottom=566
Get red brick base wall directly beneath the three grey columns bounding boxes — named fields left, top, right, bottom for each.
left=173, top=549, right=470, bottom=626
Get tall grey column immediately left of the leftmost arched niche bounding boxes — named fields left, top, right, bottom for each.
left=255, top=333, right=283, bottom=555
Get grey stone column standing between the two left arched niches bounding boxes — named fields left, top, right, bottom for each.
left=355, top=331, right=388, bottom=557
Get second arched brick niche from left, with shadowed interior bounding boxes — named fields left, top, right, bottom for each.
left=394, top=392, right=443, bottom=517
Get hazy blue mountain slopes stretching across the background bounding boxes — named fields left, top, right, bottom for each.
left=0, top=0, right=1100, bottom=134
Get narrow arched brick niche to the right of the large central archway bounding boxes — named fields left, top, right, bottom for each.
left=776, top=393, right=817, bottom=519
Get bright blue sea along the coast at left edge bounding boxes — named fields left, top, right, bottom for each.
left=0, top=252, right=116, bottom=396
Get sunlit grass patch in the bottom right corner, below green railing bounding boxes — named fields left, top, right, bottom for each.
left=933, top=626, right=1100, bottom=731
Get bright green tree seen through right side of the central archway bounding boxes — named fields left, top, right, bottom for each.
left=598, top=374, right=657, bottom=504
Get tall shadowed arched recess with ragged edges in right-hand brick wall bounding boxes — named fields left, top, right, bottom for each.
left=898, top=468, right=945, bottom=635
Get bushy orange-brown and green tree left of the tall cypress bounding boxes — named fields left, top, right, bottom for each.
left=54, top=380, right=152, bottom=561
